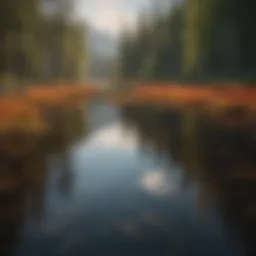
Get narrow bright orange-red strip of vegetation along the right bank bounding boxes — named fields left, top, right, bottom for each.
left=132, top=86, right=256, bottom=109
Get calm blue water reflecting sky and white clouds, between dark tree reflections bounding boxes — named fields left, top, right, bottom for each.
left=2, top=103, right=250, bottom=256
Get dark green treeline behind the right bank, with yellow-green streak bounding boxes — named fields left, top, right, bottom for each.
left=120, top=0, right=256, bottom=83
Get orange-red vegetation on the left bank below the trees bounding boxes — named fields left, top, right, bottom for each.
left=0, top=84, right=96, bottom=133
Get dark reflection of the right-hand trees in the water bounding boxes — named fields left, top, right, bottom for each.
left=121, top=106, right=256, bottom=255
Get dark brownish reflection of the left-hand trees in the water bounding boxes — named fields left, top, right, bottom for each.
left=0, top=106, right=86, bottom=256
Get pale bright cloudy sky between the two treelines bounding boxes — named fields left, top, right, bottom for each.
left=75, top=0, right=152, bottom=36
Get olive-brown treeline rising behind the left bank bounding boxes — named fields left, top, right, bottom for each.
left=0, top=0, right=87, bottom=88
